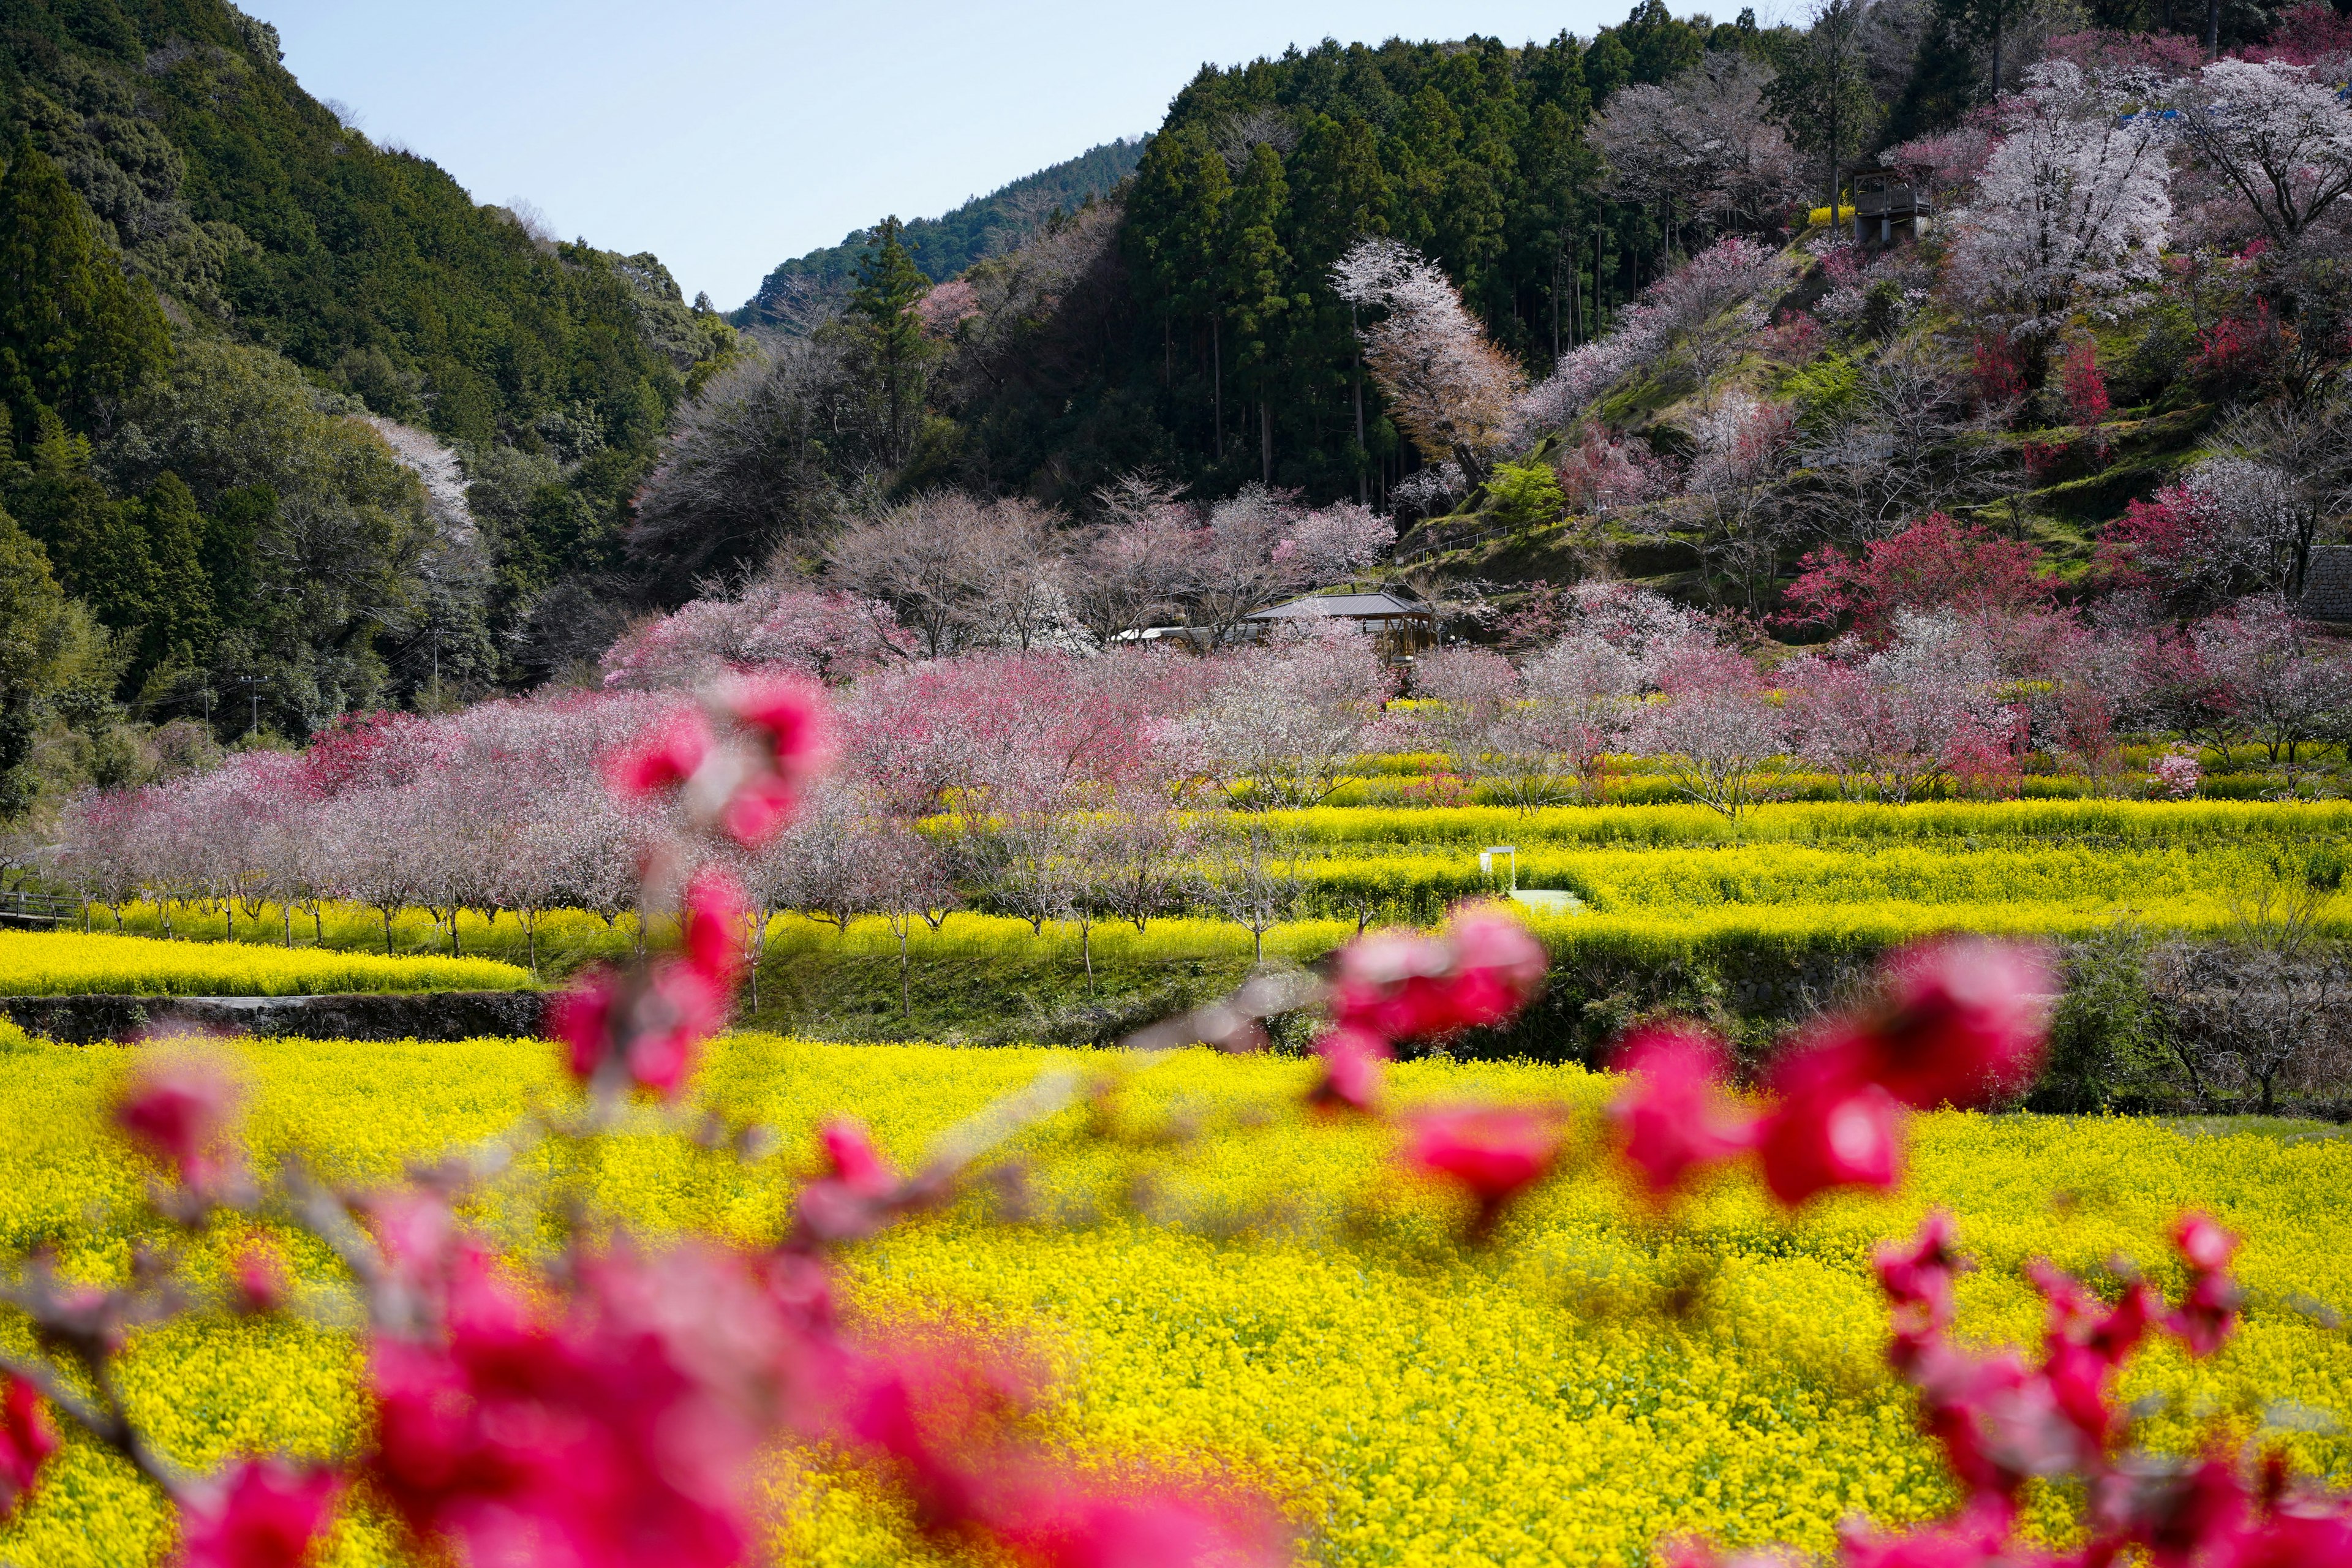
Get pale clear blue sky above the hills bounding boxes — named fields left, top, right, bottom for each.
left=243, top=0, right=1637, bottom=308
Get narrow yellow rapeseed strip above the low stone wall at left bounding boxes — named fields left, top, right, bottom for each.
left=0, top=931, right=532, bottom=997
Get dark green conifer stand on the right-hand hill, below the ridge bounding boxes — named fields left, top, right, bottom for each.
left=639, top=0, right=2049, bottom=562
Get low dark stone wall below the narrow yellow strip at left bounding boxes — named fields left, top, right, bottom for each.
left=0, top=992, right=548, bottom=1046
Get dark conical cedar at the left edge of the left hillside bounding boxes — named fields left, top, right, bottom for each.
left=0, top=141, right=172, bottom=444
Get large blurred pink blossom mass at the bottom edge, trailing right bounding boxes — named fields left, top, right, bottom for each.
left=345, top=1152, right=1282, bottom=1568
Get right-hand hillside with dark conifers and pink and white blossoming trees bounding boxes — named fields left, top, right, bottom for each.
left=630, top=0, right=2347, bottom=635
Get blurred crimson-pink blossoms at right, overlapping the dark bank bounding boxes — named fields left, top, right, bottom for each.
left=1611, top=938, right=2056, bottom=1206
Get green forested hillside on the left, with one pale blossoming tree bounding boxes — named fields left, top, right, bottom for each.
left=0, top=0, right=734, bottom=797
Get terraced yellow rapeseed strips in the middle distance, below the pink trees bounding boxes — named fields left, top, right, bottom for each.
left=64, top=799, right=2352, bottom=987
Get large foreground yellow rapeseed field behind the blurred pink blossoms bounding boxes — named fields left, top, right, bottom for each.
left=0, top=1035, right=2352, bottom=1568
